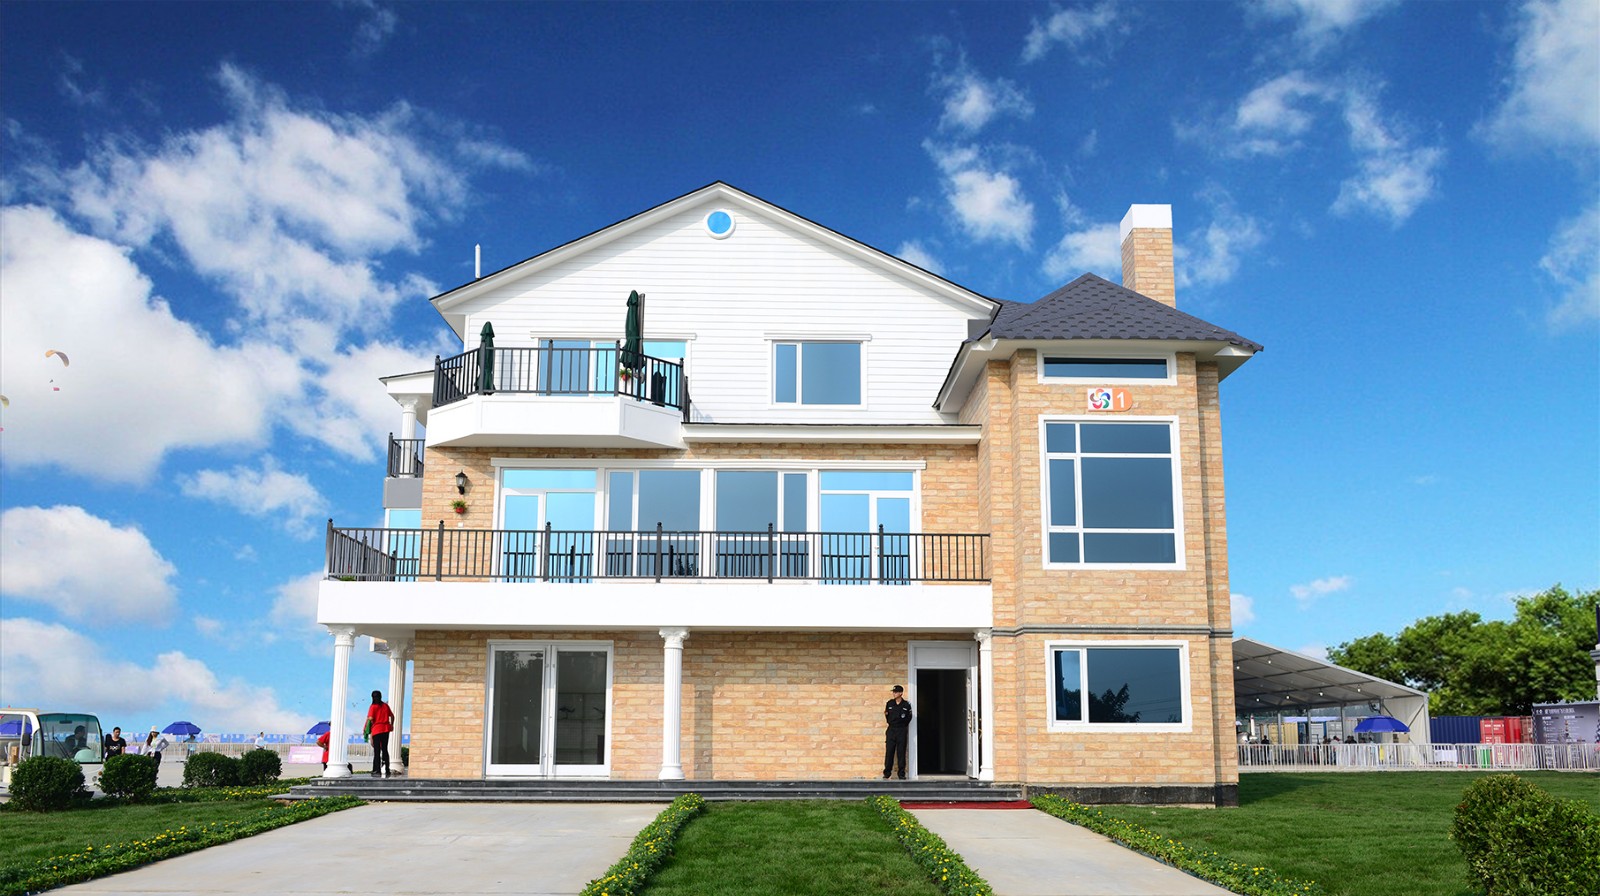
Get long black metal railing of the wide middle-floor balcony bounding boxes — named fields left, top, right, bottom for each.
left=328, top=520, right=989, bottom=586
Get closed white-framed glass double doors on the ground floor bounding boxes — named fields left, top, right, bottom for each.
left=483, top=642, right=611, bottom=778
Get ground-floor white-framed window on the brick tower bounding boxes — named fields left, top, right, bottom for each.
left=1050, top=643, right=1190, bottom=730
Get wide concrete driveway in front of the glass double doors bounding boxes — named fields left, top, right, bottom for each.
left=59, top=803, right=666, bottom=896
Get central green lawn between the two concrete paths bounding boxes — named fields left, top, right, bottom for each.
left=645, top=800, right=939, bottom=896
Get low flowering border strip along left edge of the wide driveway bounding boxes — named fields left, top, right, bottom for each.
left=0, top=797, right=363, bottom=896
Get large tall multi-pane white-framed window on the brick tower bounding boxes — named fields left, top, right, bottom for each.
left=1043, top=421, right=1179, bottom=568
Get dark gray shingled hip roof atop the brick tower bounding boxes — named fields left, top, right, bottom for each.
left=989, top=274, right=1261, bottom=352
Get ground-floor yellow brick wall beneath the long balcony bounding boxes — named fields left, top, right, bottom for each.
left=410, top=632, right=973, bottom=781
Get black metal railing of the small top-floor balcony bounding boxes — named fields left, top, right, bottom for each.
left=434, top=342, right=690, bottom=419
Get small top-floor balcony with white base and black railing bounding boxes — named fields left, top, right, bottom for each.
left=427, top=344, right=690, bottom=448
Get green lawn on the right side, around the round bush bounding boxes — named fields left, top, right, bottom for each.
left=1106, top=771, right=1600, bottom=896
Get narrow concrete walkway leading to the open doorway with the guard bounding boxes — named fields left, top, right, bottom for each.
left=910, top=810, right=1229, bottom=896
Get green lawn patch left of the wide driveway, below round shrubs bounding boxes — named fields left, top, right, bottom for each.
left=0, top=800, right=277, bottom=867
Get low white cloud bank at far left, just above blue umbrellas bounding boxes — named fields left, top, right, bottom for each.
left=0, top=618, right=315, bottom=731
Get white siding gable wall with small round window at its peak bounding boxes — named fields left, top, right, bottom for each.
left=459, top=203, right=984, bottom=424
